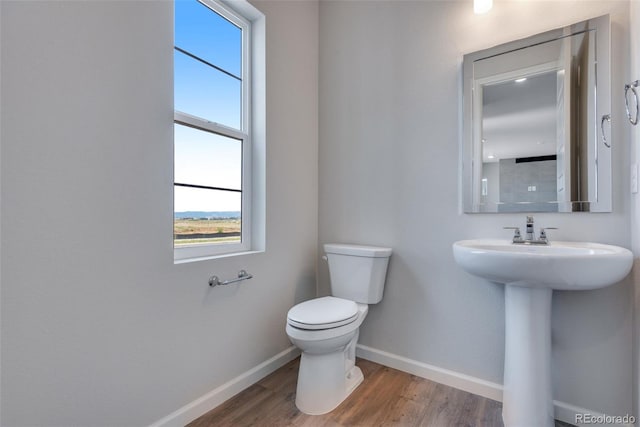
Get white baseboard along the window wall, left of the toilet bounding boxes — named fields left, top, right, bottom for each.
left=150, top=346, right=300, bottom=427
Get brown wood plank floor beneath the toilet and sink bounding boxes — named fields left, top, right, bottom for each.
left=188, top=358, right=569, bottom=427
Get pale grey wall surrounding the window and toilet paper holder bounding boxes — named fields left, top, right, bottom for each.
left=0, top=1, right=318, bottom=427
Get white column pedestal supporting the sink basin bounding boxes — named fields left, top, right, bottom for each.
left=502, top=282, right=554, bottom=427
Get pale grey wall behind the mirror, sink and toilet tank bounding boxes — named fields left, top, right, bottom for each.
left=319, top=0, right=633, bottom=415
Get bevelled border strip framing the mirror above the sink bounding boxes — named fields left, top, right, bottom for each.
left=460, top=15, right=612, bottom=213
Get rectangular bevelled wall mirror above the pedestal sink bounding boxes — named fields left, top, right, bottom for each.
left=461, top=15, right=611, bottom=213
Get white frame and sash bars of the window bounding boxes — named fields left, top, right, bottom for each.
left=172, top=0, right=256, bottom=262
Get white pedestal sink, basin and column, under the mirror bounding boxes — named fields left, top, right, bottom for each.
left=453, top=239, right=633, bottom=427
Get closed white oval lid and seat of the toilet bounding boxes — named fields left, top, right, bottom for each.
left=287, top=297, right=358, bottom=329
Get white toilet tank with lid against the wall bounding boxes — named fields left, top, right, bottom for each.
left=324, top=243, right=392, bottom=304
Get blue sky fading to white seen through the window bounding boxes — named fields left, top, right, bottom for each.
left=174, top=0, right=242, bottom=212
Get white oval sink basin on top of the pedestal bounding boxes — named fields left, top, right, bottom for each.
left=453, top=239, right=633, bottom=290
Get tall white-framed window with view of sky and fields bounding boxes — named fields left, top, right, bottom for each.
left=173, top=0, right=264, bottom=260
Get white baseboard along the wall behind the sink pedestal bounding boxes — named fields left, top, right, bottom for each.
left=356, top=344, right=634, bottom=427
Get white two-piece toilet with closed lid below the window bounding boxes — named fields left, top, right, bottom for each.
left=286, top=244, right=392, bottom=415
